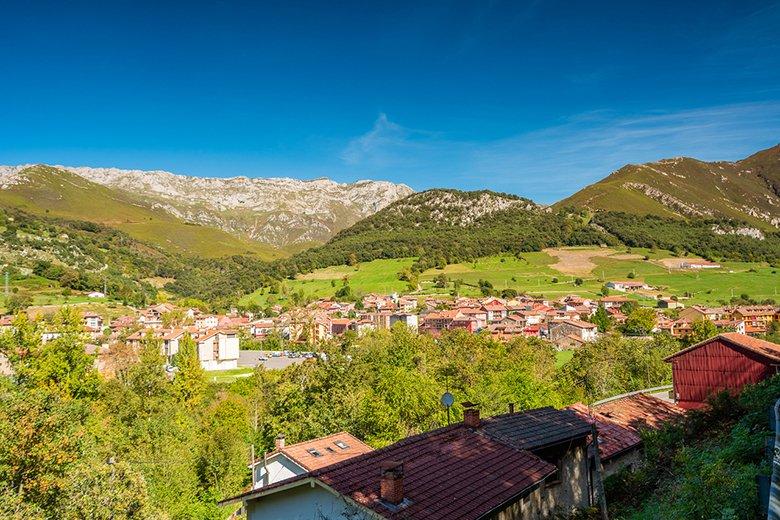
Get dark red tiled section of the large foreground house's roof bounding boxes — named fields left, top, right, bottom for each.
left=311, top=425, right=555, bottom=520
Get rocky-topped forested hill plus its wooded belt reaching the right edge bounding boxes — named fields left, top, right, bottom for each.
left=258, top=190, right=780, bottom=284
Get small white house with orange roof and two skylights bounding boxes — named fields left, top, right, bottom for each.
left=252, top=432, right=372, bottom=489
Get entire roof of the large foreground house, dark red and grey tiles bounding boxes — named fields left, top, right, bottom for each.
left=219, top=408, right=590, bottom=520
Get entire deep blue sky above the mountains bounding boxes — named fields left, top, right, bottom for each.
left=0, top=0, right=780, bottom=202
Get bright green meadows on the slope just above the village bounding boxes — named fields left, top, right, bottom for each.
left=242, top=247, right=780, bottom=305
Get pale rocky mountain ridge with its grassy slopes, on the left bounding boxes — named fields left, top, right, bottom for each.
left=0, top=165, right=412, bottom=259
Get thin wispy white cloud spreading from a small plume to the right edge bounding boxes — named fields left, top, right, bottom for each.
left=341, top=101, right=780, bottom=202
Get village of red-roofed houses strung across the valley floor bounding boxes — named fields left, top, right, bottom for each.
left=0, top=280, right=780, bottom=378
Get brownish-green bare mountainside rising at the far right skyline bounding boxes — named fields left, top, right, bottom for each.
left=555, top=145, right=780, bottom=230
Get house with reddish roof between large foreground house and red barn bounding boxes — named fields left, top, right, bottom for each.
left=568, top=392, right=684, bottom=477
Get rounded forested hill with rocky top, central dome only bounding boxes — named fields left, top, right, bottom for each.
left=272, top=189, right=617, bottom=276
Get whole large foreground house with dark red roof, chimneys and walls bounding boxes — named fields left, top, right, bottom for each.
left=220, top=408, right=595, bottom=520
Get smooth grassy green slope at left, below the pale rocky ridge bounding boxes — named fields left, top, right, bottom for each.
left=0, top=166, right=282, bottom=260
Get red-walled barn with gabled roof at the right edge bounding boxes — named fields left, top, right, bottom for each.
left=665, top=332, right=780, bottom=409
